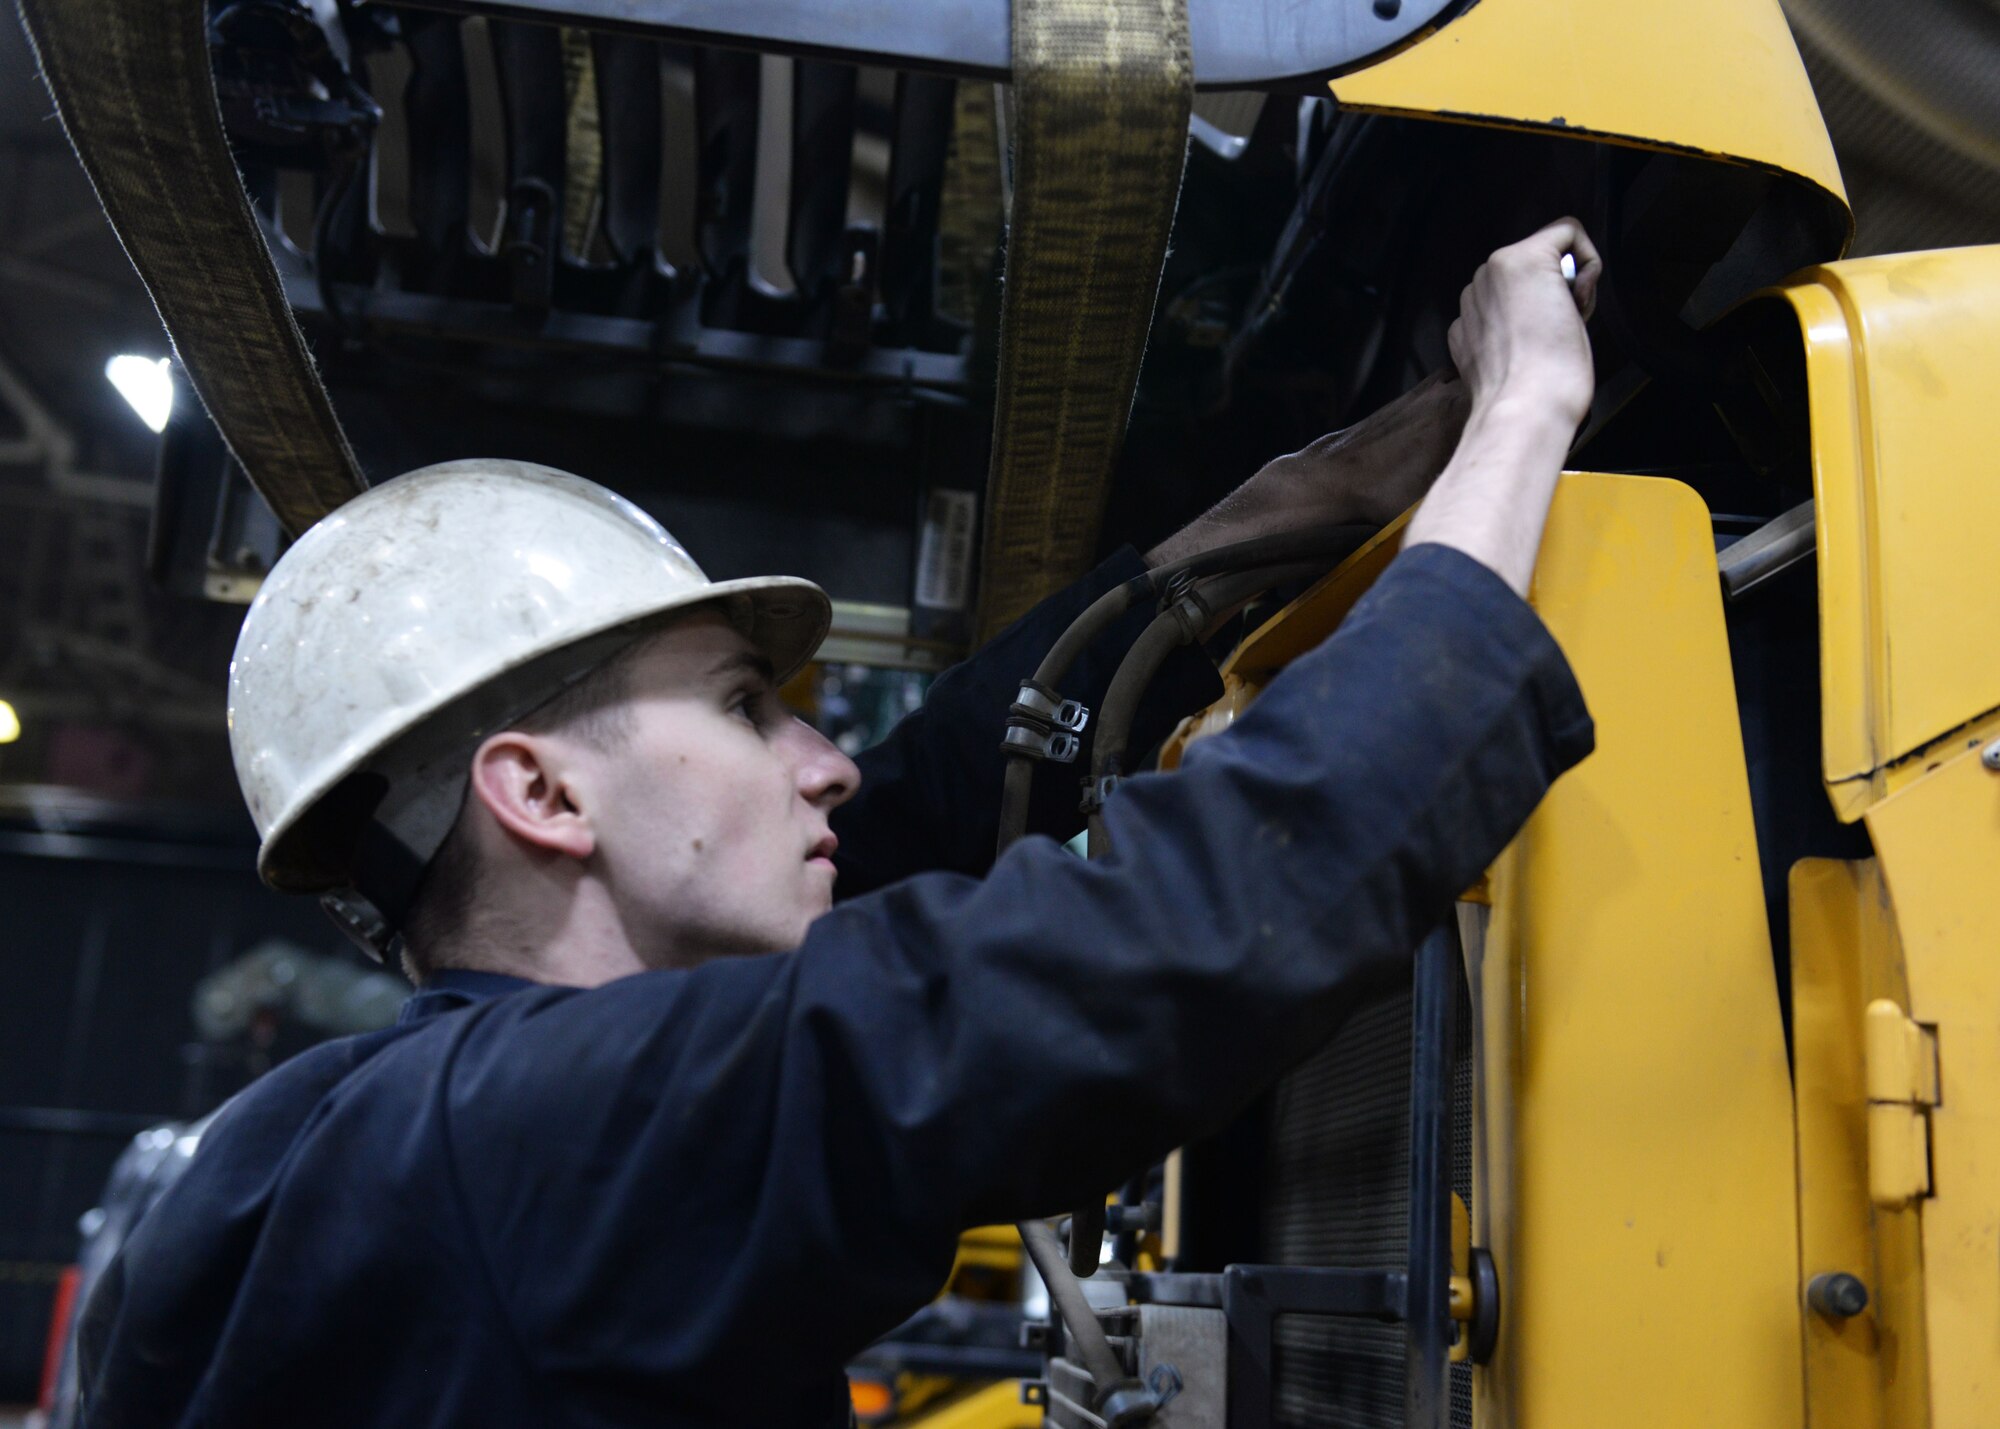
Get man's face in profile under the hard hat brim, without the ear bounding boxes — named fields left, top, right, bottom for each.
left=576, top=612, right=860, bottom=967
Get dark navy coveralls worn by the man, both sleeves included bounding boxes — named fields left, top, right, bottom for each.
left=82, top=546, right=1592, bottom=1429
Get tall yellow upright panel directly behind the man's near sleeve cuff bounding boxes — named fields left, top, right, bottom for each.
left=1182, top=472, right=1808, bottom=1429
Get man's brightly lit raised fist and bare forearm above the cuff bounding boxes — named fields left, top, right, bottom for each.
left=1402, top=218, right=1604, bottom=596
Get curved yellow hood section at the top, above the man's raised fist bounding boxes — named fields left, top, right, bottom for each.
left=1332, top=0, right=1846, bottom=212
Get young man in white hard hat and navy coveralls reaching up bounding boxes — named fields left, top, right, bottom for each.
left=84, top=220, right=1598, bottom=1425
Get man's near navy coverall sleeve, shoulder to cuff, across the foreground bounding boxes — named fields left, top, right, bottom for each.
left=448, top=546, right=1592, bottom=1423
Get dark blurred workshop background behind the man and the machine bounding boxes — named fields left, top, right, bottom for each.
left=0, top=0, right=2000, bottom=1405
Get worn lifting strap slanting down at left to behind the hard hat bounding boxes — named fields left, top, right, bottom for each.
left=20, top=0, right=366, bottom=536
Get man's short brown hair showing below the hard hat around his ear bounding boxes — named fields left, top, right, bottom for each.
left=402, top=640, right=646, bottom=987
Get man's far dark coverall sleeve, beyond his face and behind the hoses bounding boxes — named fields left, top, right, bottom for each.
left=832, top=546, right=1222, bottom=899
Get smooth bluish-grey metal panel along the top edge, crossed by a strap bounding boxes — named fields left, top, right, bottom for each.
left=382, top=0, right=1468, bottom=90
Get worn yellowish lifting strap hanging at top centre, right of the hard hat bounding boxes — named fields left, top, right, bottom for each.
left=978, top=0, right=1194, bottom=640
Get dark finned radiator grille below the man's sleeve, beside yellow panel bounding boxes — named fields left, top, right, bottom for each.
left=1264, top=964, right=1472, bottom=1429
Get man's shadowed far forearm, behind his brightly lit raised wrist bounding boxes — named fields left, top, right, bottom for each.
left=1146, top=372, right=1472, bottom=566
